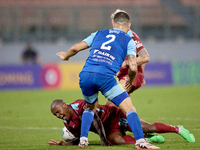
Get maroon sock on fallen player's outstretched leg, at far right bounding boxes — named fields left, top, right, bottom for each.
left=154, top=122, right=179, bottom=133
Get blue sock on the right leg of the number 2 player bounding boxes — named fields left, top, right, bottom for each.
left=126, top=110, right=144, bottom=140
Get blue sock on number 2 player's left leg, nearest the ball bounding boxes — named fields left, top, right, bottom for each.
left=80, top=109, right=94, bottom=138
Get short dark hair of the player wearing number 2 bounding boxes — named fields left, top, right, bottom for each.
left=114, top=12, right=130, bottom=24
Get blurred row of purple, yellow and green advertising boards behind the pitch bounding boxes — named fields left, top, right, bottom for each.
left=0, top=62, right=200, bottom=90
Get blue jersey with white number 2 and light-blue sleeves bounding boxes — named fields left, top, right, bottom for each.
left=82, top=28, right=136, bottom=76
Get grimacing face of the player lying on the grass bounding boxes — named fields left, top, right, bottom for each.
left=51, top=103, right=72, bottom=121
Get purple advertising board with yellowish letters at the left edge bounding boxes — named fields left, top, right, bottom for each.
left=0, top=65, right=41, bottom=90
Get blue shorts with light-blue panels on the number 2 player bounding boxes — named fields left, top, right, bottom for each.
left=79, top=71, right=129, bottom=106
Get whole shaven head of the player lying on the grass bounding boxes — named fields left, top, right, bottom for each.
left=51, top=99, right=73, bottom=120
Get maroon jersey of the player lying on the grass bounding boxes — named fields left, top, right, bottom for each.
left=64, top=99, right=131, bottom=137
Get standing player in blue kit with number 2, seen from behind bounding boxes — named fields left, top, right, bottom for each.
left=57, top=12, right=159, bottom=149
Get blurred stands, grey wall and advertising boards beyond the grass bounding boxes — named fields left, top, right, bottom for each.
left=0, top=0, right=200, bottom=90
